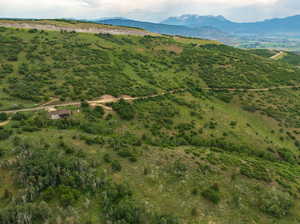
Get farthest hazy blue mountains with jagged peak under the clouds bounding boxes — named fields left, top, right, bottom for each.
left=161, top=15, right=300, bottom=34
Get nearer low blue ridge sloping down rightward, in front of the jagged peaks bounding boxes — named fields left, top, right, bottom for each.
left=93, top=18, right=232, bottom=43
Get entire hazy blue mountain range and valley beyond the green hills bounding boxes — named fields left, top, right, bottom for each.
left=91, top=15, right=300, bottom=46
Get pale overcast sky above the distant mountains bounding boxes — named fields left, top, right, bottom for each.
left=0, top=0, right=300, bottom=22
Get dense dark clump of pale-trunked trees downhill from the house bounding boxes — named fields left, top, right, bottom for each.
left=12, top=142, right=101, bottom=204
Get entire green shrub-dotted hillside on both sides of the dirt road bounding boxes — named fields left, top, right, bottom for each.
left=0, top=21, right=300, bottom=224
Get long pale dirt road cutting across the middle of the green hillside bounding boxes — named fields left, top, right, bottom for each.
left=0, top=85, right=300, bottom=114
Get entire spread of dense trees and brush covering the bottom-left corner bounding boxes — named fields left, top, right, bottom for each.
left=0, top=133, right=179, bottom=224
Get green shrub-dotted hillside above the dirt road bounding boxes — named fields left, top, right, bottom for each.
left=0, top=25, right=300, bottom=109
